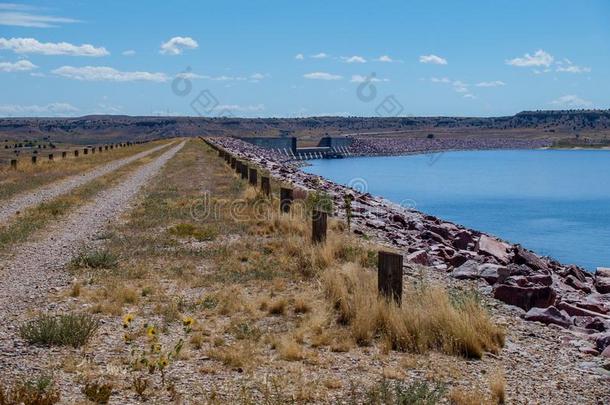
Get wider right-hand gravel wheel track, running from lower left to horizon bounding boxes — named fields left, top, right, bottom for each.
left=0, top=142, right=185, bottom=376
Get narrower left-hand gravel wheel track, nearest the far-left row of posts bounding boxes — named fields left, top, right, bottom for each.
left=0, top=144, right=173, bottom=222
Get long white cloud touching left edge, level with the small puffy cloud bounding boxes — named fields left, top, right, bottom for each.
left=0, top=38, right=110, bottom=56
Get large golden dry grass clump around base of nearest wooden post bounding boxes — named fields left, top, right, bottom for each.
left=322, top=264, right=504, bottom=358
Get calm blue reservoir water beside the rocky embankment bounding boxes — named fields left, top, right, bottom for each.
left=304, top=150, right=610, bottom=270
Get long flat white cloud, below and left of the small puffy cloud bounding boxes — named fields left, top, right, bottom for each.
left=52, top=66, right=169, bottom=82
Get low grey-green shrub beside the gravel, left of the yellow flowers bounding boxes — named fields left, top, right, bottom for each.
left=20, top=314, right=99, bottom=347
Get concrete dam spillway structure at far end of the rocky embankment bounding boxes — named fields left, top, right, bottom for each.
left=237, top=136, right=352, bottom=160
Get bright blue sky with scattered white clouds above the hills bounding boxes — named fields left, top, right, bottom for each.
left=0, top=0, right=610, bottom=117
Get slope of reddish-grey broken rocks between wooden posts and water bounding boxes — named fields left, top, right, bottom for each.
left=212, top=138, right=610, bottom=398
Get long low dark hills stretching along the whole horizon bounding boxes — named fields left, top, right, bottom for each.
left=0, top=110, right=610, bottom=144
